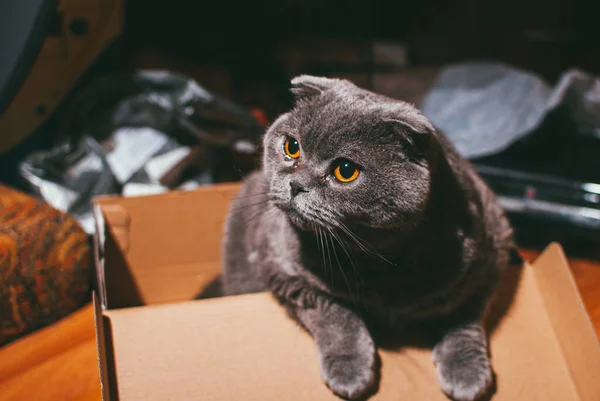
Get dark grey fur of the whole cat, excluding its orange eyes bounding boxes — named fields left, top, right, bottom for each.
left=222, top=76, right=513, bottom=400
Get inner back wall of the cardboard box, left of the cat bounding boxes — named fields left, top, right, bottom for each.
left=94, top=183, right=239, bottom=309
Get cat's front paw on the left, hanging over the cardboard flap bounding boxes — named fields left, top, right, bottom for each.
left=321, top=353, right=376, bottom=400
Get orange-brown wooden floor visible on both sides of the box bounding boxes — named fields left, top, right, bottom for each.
left=0, top=251, right=600, bottom=401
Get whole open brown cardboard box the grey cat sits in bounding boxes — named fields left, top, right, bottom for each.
left=95, top=184, right=600, bottom=401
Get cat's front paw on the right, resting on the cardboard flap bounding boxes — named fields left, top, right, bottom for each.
left=436, top=348, right=493, bottom=401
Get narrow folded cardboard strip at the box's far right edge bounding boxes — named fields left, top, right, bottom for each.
left=532, top=243, right=600, bottom=401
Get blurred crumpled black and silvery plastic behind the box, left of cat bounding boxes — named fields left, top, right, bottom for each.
left=21, top=71, right=266, bottom=234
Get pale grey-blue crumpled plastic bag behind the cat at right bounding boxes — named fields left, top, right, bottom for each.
left=422, top=63, right=600, bottom=158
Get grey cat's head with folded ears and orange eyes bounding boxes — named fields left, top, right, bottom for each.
left=263, top=76, right=434, bottom=228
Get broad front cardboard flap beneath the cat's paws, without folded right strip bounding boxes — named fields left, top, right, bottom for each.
left=105, top=253, right=592, bottom=401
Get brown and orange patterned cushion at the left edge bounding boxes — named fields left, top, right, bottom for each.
left=0, top=184, right=92, bottom=345
